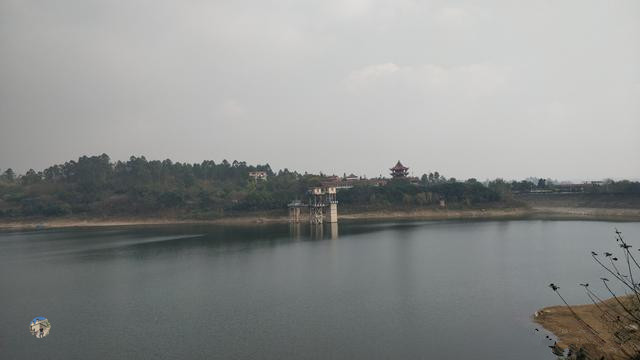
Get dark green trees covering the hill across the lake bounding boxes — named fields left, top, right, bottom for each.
left=0, top=154, right=640, bottom=218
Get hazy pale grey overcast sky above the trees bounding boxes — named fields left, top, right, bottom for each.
left=0, top=0, right=640, bottom=179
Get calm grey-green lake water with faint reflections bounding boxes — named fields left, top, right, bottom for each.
left=0, top=221, right=640, bottom=360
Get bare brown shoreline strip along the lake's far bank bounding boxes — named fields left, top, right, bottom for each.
left=0, top=207, right=640, bottom=230
